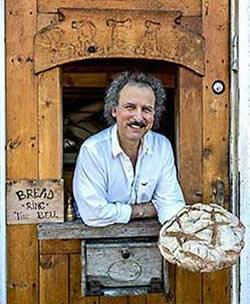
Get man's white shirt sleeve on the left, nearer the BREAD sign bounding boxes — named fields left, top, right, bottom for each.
left=73, top=145, right=132, bottom=227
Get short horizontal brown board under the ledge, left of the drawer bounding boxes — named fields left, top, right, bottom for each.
left=39, top=239, right=81, bottom=254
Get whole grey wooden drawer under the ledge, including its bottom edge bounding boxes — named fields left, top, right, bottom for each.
left=82, top=241, right=164, bottom=295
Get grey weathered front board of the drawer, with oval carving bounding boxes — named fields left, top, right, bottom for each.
left=85, top=241, right=163, bottom=287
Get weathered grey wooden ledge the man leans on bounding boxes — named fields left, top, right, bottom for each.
left=37, top=219, right=161, bottom=240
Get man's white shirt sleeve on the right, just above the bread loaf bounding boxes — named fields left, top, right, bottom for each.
left=152, top=141, right=185, bottom=224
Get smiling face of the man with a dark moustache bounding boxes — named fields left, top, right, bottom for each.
left=112, top=85, right=155, bottom=144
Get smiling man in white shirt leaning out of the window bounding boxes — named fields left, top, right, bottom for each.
left=73, top=72, right=184, bottom=226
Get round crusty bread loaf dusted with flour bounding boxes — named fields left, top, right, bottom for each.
left=159, top=204, right=245, bottom=272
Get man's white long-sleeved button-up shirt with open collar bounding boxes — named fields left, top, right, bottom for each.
left=73, top=124, right=185, bottom=226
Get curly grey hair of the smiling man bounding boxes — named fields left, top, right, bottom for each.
left=104, top=71, right=166, bottom=129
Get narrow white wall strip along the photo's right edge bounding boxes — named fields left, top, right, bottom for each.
left=239, top=0, right=250, bottom=304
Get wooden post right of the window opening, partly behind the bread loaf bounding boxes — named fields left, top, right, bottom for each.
left=175, top=67, right=202, bottom=304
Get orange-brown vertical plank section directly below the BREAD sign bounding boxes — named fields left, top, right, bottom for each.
left=7, top=225, right=39, bottom=304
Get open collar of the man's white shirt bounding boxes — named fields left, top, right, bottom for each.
left=111, top=124, right=152, bottom=157
